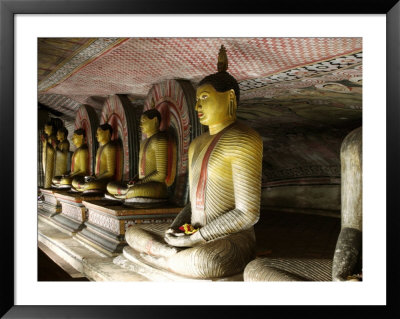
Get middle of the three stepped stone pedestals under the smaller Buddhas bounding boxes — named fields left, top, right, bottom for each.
left=53, top=190, right=102, bottom=233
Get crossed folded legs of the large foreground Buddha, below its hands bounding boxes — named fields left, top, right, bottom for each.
left=125, top=226, right=255, bottom=279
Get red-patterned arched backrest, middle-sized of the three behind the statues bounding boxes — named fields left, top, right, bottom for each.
left=100, top=94, right=139, bottom=181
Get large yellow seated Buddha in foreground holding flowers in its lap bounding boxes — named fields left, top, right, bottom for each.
left=124, top=46, right=262, bottom=279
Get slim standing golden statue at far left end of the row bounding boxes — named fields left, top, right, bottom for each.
left=41, top=121, right=57, bottom=188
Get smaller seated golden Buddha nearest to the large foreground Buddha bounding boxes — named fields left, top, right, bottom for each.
left=107, top=109, right=173, bottom=204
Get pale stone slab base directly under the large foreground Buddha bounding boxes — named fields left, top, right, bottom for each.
left=113, top=246, right=243, bottom=281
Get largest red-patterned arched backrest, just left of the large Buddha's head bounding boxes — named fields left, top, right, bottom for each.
left=142, top=80, right=202, bottom=205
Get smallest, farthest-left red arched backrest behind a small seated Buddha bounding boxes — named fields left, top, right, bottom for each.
left=75, top=105, right=99, bottom=175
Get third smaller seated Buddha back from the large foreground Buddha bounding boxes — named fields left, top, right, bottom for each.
left=53, top=128, right=89, bottom=188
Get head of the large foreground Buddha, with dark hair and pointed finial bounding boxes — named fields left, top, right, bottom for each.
left=195, top=46, right=240, bottom=126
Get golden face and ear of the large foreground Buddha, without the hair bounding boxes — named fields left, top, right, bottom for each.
left=195, top=84, right=236, bottom=126
